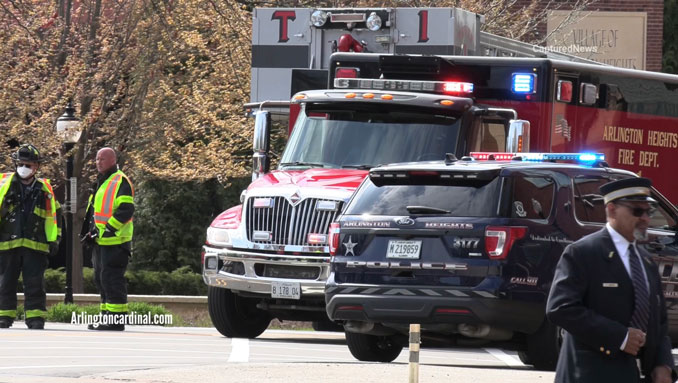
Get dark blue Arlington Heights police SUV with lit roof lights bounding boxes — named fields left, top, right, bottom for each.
left=325, top=153, right=678, bottom=369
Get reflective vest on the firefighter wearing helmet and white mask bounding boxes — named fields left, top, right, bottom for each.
left=0, top=173, right=58, bottom=253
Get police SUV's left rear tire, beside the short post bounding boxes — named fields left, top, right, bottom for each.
left=345, top=331, right=403, bottom=363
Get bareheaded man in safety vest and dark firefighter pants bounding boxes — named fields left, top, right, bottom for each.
left=83, top=148, right=134, bottom=331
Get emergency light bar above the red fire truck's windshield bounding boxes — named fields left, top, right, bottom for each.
left=334, top=78, right=473, bottom=95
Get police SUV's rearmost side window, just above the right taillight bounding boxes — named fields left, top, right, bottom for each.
left=511, top=176, right=555, bottom=219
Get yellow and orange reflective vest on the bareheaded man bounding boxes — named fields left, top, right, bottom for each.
left=88, top=170, right=134, bottom=246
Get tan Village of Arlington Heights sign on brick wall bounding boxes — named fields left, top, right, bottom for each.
left=544, top=11, right=647, bottom=69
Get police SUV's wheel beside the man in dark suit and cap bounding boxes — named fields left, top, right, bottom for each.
left=518, top=319, right=563, bottom=371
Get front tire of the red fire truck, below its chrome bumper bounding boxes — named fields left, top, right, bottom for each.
left=207, top=286, right=271, bottom=338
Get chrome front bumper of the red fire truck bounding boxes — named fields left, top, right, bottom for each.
left=202, top=246, right=330, bottom=300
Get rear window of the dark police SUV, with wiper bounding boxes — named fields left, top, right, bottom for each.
left=346, top=177, right=502, bottom=217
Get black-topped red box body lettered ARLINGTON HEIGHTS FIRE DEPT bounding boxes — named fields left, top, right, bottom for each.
left=331, top=54, right=678, bottom=204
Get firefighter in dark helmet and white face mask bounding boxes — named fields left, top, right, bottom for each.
left=0, top=144, right=59, bottom=329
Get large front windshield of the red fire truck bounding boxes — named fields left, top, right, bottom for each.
left=280, top=104, right=461, bottom=169
